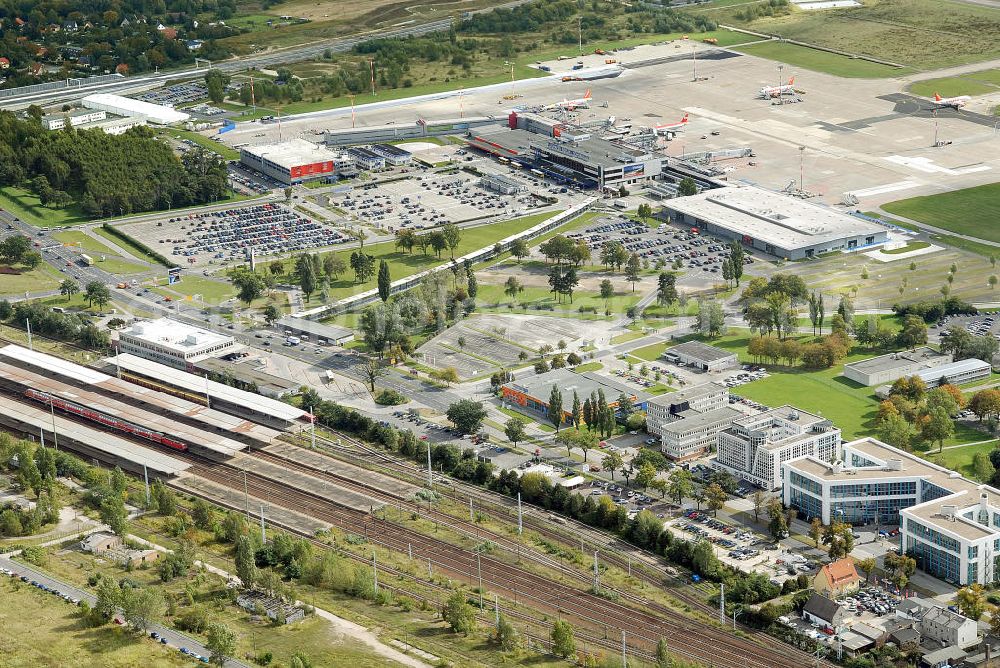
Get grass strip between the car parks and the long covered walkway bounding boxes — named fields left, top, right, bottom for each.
left=300, top=212, right=555, bottom=301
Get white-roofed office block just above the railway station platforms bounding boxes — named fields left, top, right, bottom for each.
left=117, top=318, right=236, bottom=370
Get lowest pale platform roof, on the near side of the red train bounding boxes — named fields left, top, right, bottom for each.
left=0, top=396, right=190, bottom=478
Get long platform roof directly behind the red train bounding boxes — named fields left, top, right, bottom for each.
left=0, top=361, right=249, bottom=459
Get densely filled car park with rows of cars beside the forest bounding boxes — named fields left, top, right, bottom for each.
left=125, top=204, right=350, bottom=266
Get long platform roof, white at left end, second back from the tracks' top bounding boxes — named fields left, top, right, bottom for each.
left=0, top=345, right=281, bottom=447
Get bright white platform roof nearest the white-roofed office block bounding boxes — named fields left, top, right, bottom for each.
left=104, top=353, right=309, bottom=431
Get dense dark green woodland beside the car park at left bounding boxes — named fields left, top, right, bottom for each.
left=0, top=112, right=229, bottom=216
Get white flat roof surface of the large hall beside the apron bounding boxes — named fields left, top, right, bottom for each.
left=668, top=186, right=886, bottom=250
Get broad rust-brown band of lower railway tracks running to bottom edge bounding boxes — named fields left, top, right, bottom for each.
left=184, top=456, right=816, bottom=668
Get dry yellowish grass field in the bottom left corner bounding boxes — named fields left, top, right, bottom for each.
left=0, top=577, right=191, bottom=668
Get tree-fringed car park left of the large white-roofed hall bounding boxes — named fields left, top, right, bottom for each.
left=566, top=215, right=754, bottom=277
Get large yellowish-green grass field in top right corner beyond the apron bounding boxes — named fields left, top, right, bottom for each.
left=724, top=0, right=1000, bottom=72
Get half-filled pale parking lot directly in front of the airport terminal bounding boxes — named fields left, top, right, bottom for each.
left=330, top=174, right=534, bottom=231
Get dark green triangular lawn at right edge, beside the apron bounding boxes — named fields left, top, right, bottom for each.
left=882, top=183, right=1000, bottom=241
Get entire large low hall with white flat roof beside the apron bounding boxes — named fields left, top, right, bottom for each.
left=663, top=185, right=888, bottom=260
